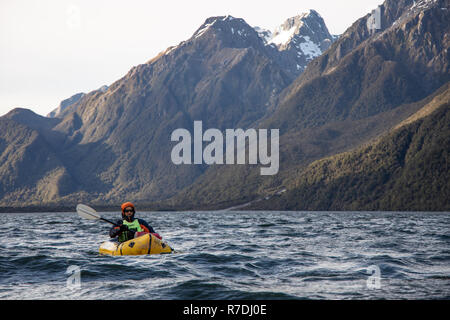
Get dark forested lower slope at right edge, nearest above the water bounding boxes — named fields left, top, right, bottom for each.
left=248, top=84, right=450, bottom=211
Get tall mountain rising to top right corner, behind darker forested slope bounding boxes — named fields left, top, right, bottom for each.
left=162, top=1, right=450, bottom=210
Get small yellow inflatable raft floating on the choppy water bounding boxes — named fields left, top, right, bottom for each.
left=99, top=233, right=173, bottom=256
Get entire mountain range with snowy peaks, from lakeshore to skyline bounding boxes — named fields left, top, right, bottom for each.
left=0, top=0, right=450, bottom=210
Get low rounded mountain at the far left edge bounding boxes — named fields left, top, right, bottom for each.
left=0, top=109, right=77, bottom=205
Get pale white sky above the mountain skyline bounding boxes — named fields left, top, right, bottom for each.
left=0, top=0, right=383, bottom=116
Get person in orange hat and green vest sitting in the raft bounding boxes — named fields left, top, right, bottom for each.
left=109, top=202, right=162, bottom=242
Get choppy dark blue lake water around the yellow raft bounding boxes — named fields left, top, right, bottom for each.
left=0, top=211, right=450, bottom=299
